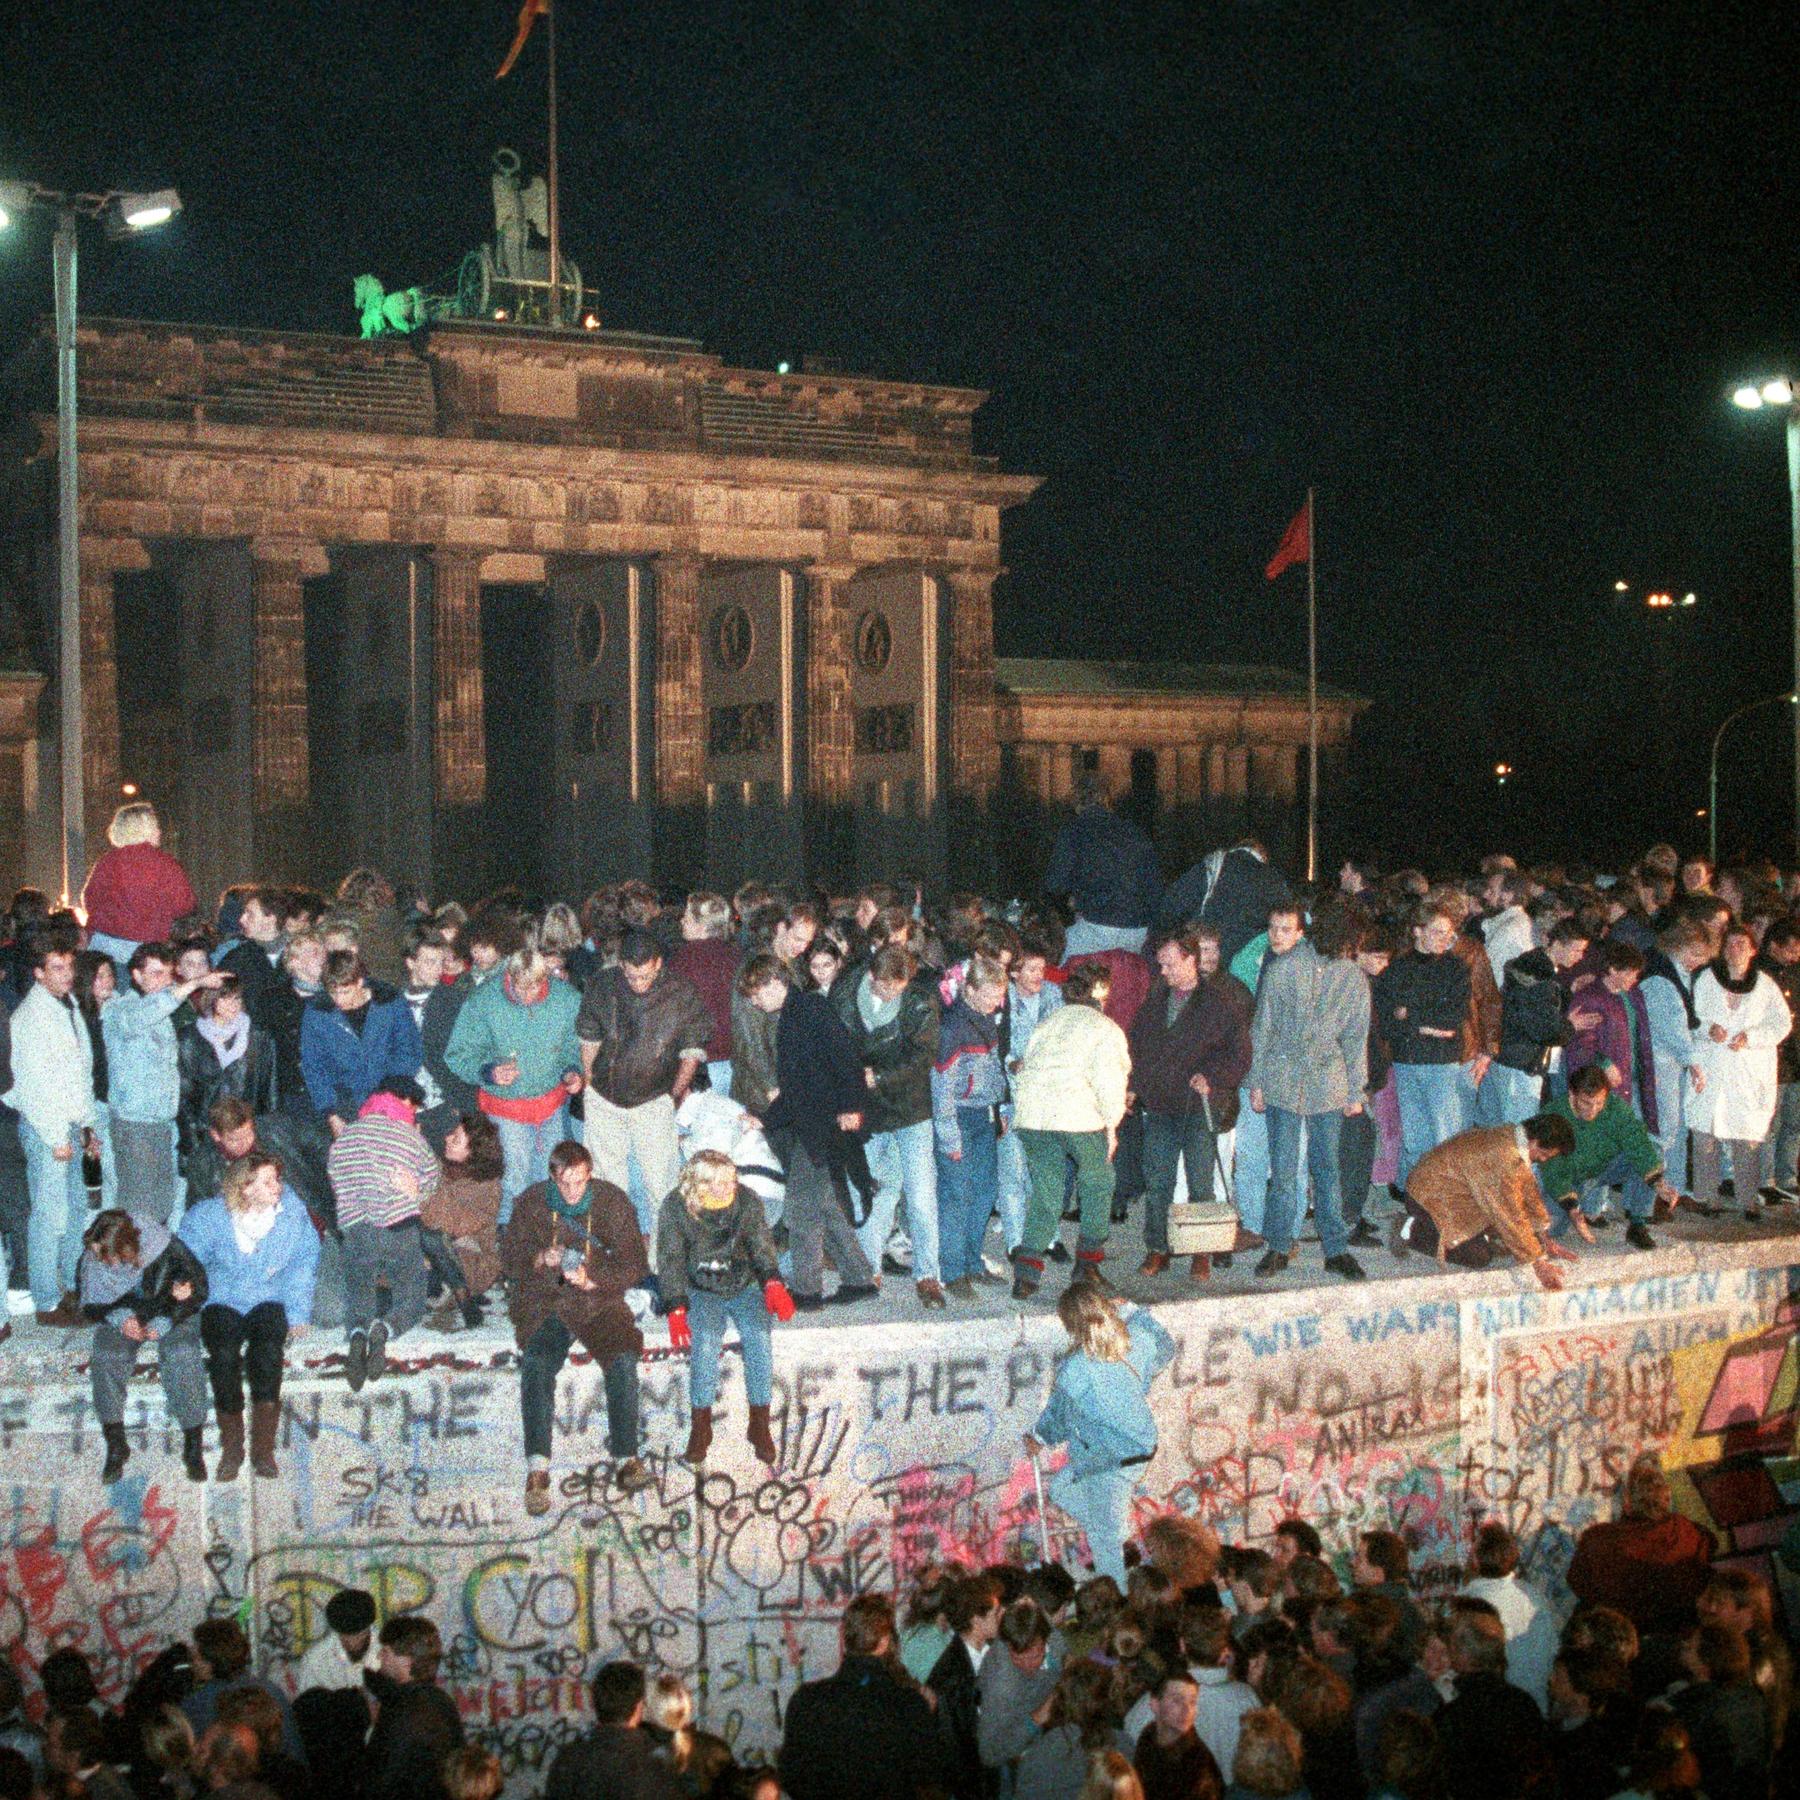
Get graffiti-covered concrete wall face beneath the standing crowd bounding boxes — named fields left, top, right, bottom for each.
left=0, top=1244, right=1800, bottom=1795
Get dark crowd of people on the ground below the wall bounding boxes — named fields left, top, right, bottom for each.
left=0, top=1454, right=1800, bottom=1800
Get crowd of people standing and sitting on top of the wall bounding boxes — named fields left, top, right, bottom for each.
left=0, top=792, right=1800, bottom=1490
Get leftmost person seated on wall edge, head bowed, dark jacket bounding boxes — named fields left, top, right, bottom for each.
left=77, top=1206, right=207, bottom=1481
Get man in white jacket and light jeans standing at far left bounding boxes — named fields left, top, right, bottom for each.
left=5, top=936, right=95, bottom=1328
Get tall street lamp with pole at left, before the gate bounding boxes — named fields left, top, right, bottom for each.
left=0, top=182, right=182, bottom=905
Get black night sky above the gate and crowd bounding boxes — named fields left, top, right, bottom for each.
left=0, top=0, right=1800, bottom=860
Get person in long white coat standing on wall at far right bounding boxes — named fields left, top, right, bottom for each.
left=1687, top=925, right=1793, bottom=1219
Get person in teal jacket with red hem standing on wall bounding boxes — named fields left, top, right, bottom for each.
left=445, top=943, right=581, bottom=1231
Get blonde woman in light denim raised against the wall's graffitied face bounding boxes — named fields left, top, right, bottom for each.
left=1024, top=1276, right=1175, bottom=1588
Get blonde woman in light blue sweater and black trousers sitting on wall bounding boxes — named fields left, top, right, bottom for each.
left=182, top=1150, right=319, bottom=1481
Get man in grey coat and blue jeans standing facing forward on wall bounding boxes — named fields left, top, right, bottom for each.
left=1249, top=905, right=1368, bottom=1282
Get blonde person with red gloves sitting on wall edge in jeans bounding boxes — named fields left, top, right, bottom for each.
left=657, top=1150, right=794, bottom=1469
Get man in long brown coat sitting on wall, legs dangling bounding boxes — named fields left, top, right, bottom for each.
left=500, top=1139, right=652, bottom=1519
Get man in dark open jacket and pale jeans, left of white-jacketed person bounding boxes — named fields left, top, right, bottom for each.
left=832, top=943, right=943, bottom=1307
